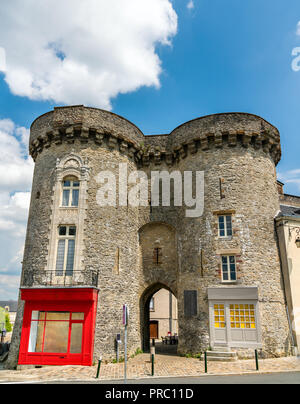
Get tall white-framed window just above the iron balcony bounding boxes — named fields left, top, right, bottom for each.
left=56, top=226, right=76, bottom=276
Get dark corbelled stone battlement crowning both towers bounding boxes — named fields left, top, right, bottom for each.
left=29, top=106, right=281, bottom=166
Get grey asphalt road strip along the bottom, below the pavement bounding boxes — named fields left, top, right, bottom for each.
left=15, top=372, right=300, bottom=385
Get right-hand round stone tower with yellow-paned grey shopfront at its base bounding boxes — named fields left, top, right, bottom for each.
left=141, top=113, right=291, bottom=356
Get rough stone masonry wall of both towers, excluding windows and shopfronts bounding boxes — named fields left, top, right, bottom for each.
left=9, top=106, right=289, bottom=367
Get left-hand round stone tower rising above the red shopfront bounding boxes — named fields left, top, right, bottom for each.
left=8, top=106, right=143, bottom=364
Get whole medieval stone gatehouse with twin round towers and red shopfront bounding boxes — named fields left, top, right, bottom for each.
left=8, top=106, right=298, bottom=367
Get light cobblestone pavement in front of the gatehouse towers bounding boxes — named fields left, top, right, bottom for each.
left=0, top=354, right=300, bottom=383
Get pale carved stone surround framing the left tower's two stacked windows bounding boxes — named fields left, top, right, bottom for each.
left=47, top=153, right=89, bottom=272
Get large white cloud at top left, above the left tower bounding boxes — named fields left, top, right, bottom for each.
left=0, top=0, right=177, bottom=109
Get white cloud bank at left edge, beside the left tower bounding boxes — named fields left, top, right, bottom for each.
left=0, top=119, right=33, bottom=300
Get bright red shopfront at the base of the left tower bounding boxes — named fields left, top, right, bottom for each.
left=19, top=288, right=98, bottom=366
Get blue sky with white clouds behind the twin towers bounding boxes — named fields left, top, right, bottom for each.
left=0, top=0, right=300, bottom=299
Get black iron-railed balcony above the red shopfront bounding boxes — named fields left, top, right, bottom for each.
left=21, top=271, right=99, bottom=288
